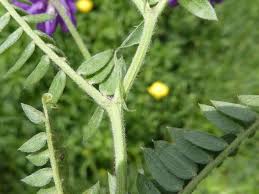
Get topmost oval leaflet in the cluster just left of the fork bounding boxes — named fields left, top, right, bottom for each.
left=77, top=50, right=113, bottom=76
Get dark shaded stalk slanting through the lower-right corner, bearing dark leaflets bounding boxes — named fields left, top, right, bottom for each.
left=179, top=120, right=259, bottom=194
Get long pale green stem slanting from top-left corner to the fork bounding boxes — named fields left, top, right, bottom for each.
left=0, top=0, right=109, bottom=107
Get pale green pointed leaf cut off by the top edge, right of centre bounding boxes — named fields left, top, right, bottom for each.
left=178, top=0, right=218, bottom=20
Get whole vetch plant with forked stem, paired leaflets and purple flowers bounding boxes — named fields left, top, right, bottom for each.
left=0, top=0, right=259, bottom=194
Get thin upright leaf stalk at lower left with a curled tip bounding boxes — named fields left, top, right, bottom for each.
left=42, top=96, right=64, bottom=194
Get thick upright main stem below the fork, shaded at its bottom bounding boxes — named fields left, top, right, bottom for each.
left=107, top=103, right=127, bottom=194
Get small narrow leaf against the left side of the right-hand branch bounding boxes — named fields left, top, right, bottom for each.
left=120, top=22, right=144, bottom=48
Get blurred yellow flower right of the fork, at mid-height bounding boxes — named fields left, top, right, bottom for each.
left=148, top=81, right=169, bottom=100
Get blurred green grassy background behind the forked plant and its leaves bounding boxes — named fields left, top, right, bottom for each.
left=0, top=0, right=259, bottom=194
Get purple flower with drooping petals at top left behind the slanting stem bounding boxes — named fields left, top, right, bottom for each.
left=12, top=0, right=76, bottom=35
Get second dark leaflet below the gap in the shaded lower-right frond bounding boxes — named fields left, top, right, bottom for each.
left=169, top=128, right=212, bottom=164
